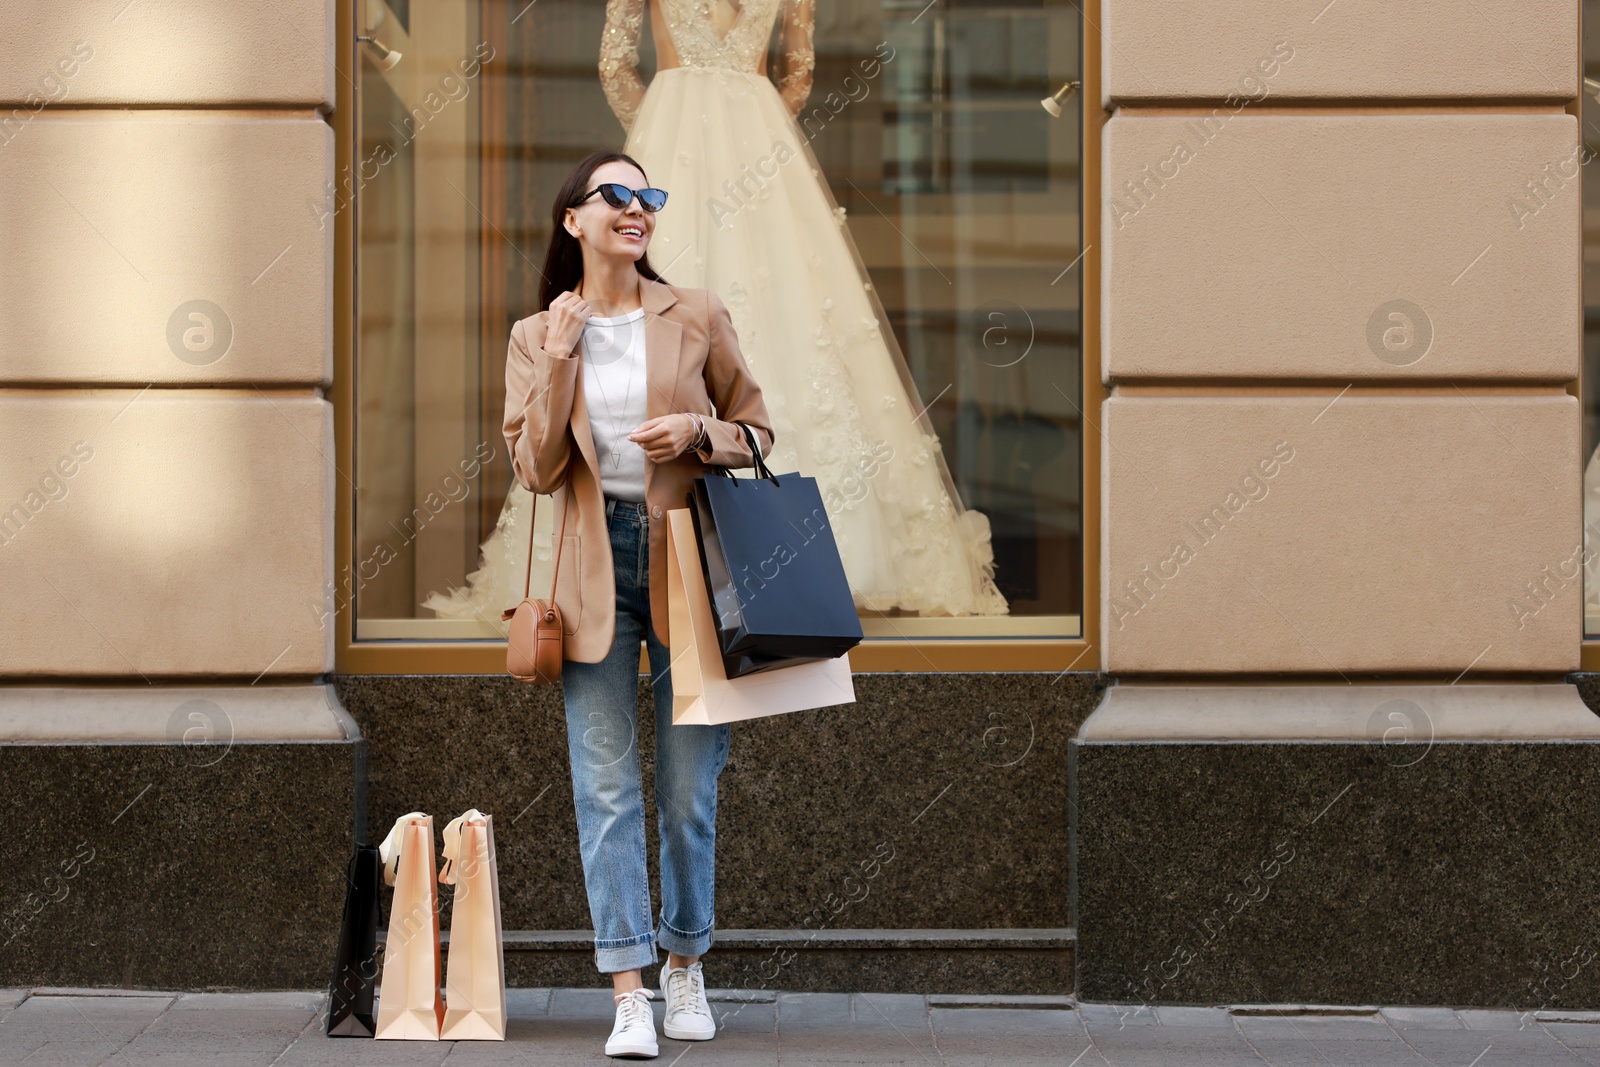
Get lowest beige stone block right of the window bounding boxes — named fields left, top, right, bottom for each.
left=1102, top=389, right=1582, bottom=677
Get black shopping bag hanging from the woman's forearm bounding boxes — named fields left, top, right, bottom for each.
left=690, top=422, right=861, bottom=678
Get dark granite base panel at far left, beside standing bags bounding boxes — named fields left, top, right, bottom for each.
left=0, top=741, right=365, bottom=990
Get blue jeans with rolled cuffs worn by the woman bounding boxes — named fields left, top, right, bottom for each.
left=562, top=498, right=733, bottom=973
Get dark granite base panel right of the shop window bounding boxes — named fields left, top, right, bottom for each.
left=1072, top=742, right=1600, bottom=1009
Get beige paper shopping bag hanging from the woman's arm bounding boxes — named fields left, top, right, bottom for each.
left=667, top=509, right=856, bottom=726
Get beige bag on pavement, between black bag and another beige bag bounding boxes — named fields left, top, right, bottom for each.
left=373, top=811, right=445, bottom=1041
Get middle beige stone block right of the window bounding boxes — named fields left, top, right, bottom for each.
left=1102, top=109, right=1582, bottom=386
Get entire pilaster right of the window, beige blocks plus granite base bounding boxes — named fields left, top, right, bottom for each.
left=1074, top=0, right=1600, bottom=1008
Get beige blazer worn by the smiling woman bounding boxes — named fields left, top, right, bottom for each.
left=506, top=277, right=773, bottom=664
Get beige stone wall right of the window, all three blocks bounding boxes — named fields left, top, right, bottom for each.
left=1101, top=0, right=1582, bottom=681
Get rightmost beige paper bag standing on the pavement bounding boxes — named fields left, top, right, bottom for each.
left=438, top=808, right=506, bottom=1041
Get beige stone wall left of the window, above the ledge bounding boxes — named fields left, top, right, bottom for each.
left=0, top=0, right=339, bottom=684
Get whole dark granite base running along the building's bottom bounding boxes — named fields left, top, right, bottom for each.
left=12, top=673, right=1600, bottom=1009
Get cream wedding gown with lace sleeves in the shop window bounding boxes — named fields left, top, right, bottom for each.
left=422, top=0, right=1008, bottom=627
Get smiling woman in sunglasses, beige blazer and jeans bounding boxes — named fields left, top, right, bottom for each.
left=506, top=152, right=773, bottom=1056
